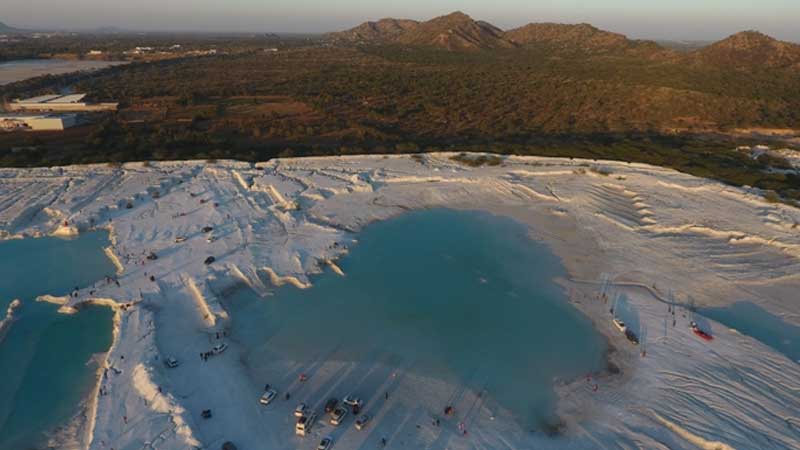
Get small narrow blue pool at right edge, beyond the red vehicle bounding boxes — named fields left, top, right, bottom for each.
left=700, top=302, right=800, bottom=363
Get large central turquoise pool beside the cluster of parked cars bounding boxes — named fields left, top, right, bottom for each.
left=226, top=209, right=606, bottom=428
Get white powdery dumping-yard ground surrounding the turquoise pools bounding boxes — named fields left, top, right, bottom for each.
left=0, top=154, right=800, bottom=450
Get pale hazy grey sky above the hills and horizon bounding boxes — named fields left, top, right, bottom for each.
left=6, top=0, right=800, bottom=42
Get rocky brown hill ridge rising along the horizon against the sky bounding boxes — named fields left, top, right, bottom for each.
left=327, top=12, right=800, bottom=69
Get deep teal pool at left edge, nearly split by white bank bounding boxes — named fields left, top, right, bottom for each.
left=0, top=232, right=114, bottom=450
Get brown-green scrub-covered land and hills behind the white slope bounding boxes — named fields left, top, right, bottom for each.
left=0, top=16, right=800, bottom=204
